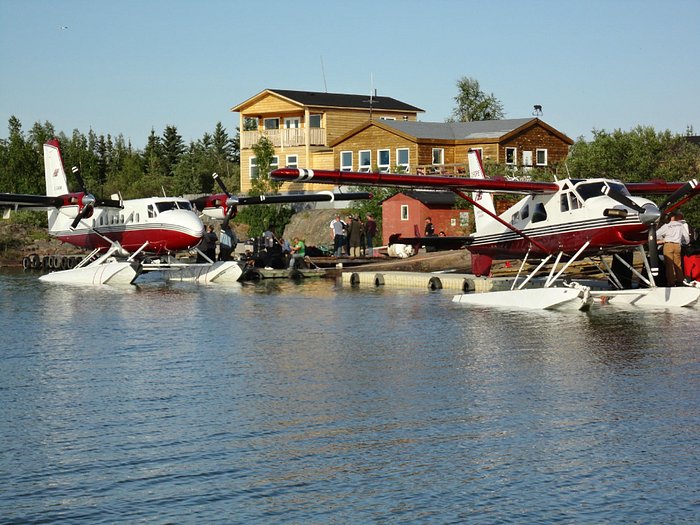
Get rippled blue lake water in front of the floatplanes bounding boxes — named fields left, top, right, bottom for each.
left=0, top=271, right=700, bottom=524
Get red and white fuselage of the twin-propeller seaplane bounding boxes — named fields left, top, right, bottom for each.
left=48, top=197, right=204, bottom=253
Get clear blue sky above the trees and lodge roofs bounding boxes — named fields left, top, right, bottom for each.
left=0, top=0, right=700, bottom=148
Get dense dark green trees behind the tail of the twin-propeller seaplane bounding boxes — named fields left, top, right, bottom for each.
left=0, top=116, right=240, bottom=203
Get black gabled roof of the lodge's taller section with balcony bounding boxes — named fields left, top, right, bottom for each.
left=231, top=89, right=424, bottom=113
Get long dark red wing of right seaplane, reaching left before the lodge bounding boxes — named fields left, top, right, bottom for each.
left=270, top=168, right=559, bottom=193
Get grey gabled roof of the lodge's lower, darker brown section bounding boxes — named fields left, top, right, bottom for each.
left=331, top=118, right=574, bottom=146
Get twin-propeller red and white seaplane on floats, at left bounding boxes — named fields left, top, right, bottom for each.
left=0, top=139, right=369, bottom=284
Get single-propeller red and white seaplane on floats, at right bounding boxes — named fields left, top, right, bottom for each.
left=271, top=150, right=700, bottom=310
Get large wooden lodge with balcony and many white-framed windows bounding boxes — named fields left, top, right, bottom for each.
left=231, top=89, right=573, bottom=193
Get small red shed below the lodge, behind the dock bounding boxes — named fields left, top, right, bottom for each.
left=382, top=191, right=470, bottom=244
